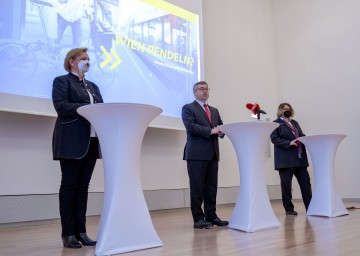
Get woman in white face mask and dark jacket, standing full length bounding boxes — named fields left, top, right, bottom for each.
left=52, top=48, right=103, bottom=248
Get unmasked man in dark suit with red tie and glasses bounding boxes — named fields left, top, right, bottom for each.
left=182, top=81, right=228, bottom=228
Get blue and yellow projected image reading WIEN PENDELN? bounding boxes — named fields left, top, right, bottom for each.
left=0, top=0, right=200, bottom=117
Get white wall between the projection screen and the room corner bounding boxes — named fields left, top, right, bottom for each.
left=203, top=0, right=279, bottom=186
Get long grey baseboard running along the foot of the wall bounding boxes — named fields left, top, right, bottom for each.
left=0, top=185, right=360, bottom=224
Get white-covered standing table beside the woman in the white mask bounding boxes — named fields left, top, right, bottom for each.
left=78, top=103, right=163, bottom=256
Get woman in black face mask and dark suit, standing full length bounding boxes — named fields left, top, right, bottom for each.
left=270, top=103, right=312, bottom=215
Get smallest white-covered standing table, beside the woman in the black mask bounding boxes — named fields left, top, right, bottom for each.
left=299, top=134, right=349, bottom=217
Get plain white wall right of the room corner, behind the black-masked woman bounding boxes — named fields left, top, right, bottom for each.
left=272, top=0, right=360, bottom=198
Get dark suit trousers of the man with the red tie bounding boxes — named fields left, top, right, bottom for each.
left=187, top=158, right=219, bottom=222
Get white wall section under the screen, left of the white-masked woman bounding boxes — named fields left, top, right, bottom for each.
left=0, top=112, right=60, bottom=195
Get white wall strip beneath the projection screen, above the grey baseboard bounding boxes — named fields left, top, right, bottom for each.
left=0, top=112, right=188, bottom=196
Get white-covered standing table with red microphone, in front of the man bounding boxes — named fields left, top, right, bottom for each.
left=220, top=121, right=280, bottom=232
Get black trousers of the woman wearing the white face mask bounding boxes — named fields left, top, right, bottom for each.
left=59, top=138, right=99, bottom=236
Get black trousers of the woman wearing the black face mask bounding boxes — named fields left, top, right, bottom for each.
left=279, top=166, right=312, bottom=212
